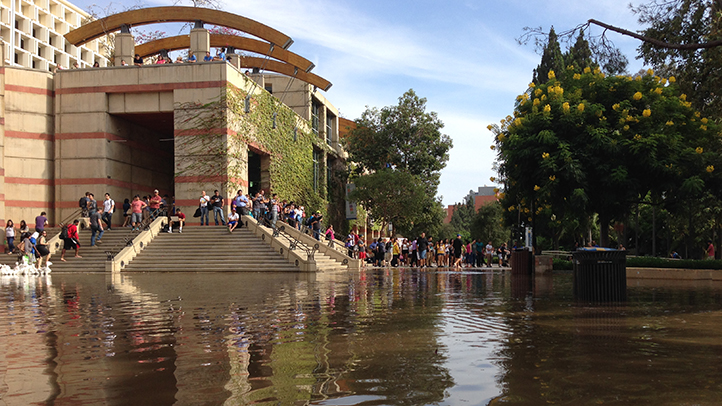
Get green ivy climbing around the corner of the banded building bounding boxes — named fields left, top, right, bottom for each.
left=176, top=78, right=345, bottom=219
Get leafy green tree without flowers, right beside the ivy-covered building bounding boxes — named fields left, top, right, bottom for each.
left=344, top=90, right=452, bottom=233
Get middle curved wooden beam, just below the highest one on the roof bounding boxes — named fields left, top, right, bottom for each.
left=135, top=34, right=314, bottom=72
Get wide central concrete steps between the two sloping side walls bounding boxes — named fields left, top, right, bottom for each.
left=122, top=226, right=298, bottom=272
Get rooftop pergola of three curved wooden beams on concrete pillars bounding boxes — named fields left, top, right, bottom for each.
left=65, top=6, right=331, bottom=91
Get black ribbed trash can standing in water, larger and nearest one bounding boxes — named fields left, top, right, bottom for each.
left=572, top=250, right=627, bottom=303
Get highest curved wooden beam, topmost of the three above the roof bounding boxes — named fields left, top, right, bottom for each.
left=65, top=6, right=293, bottom=49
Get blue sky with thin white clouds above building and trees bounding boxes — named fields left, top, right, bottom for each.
left=74, top=0, right=643, bottom=205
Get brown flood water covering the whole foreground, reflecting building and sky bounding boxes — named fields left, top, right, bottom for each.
left=0, top=269, right=722, bottom=405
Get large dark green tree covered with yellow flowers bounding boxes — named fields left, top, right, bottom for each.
left=492, top=68, right=722, bottom=244
